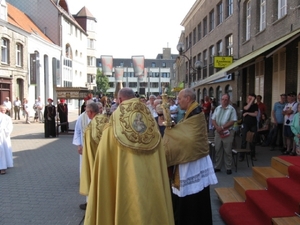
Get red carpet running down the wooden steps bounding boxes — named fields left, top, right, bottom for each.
left=220, top=156, right=300, bottom=225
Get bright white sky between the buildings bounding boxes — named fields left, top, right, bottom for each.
left=67, top=0, right=196, bottom=59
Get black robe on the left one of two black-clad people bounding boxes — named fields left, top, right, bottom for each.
left=44, top=105, right=56, bottom=137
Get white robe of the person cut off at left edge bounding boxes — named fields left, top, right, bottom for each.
left=0, top=113, right=14, bottom=170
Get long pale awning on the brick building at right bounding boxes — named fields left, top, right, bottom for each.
left=193, top=29, right=300, bottom=87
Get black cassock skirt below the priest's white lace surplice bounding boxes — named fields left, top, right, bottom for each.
left=172, top=186, right=212, bottom=225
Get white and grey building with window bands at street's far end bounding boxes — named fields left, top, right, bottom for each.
left=97, top=48, right=178, bottom=96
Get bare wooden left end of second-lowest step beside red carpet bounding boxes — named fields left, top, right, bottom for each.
left=234, top=177, right=265, bottom=199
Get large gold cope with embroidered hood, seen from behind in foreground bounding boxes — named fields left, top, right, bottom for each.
left=84, top=98, right=174, bottom=225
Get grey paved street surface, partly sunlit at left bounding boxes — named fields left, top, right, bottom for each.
left=0, top=111, right=280, bottom=225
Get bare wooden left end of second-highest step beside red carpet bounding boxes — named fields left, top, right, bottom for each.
left=252, top=167, right=286, bottom=187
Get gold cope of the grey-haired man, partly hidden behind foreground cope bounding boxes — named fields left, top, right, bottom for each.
left=79, top=114, right=108, bottom=196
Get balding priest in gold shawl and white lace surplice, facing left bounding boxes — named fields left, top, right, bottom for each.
left=163, top=89, right=218, bottom=225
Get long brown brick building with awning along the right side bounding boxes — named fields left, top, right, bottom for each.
left=176, top=0, right=300, bottom=115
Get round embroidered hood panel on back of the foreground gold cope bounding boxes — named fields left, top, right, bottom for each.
left=112, top=98, right=161, bottom=154
